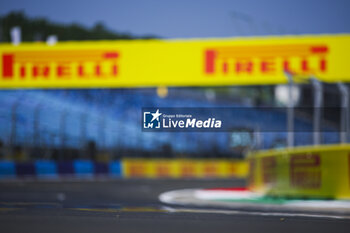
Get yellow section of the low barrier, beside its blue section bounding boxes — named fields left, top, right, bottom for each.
left=122, top=159, right=248, bottom=178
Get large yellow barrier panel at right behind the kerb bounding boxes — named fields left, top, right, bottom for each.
left=248, top=144, right=350, bottom=199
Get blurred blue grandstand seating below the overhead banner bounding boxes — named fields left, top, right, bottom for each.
left=0, top=86, right=339, bottom=160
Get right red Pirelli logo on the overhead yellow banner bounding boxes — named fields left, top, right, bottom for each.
left=204, top=44, right=329, bottom=75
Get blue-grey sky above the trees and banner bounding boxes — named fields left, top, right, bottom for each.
left=0, top=0, right=350, bottom=38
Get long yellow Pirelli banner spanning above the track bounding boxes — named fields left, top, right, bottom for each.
left=0, top=34, right=350, bottom=88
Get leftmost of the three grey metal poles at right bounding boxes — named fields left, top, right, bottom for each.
left=286, top=73, right=294, bottom=147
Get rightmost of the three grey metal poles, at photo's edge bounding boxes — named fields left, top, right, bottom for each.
left=337, top=82, right=349, bottom=143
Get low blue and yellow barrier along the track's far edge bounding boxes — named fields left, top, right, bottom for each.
left=0, top=159, right=248, bottom=179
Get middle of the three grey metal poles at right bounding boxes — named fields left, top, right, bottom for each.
left=311, top=78, right=323, bottom=145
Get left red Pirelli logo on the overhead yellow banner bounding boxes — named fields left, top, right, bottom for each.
left=1, top=50, right=120, bottom=80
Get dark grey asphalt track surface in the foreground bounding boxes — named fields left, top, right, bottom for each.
left=0, top=180, right=350, bottom=233
